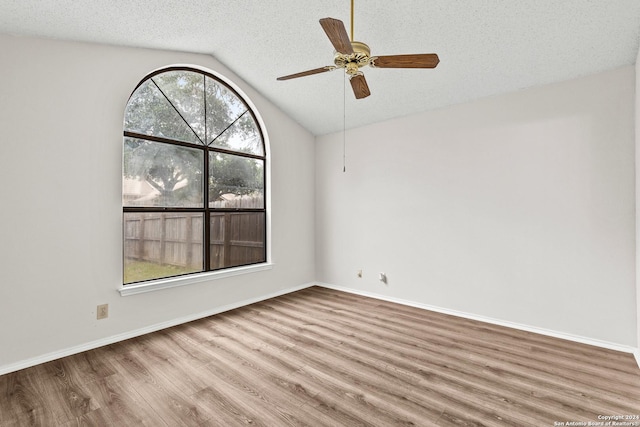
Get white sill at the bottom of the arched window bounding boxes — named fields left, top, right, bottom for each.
left=118, top=263, right=273, bottom=297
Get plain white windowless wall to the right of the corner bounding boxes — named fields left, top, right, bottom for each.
left=316, top=66, right=637, bottom=347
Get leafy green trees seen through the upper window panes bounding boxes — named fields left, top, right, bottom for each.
left=124, top=70, right=264, bottom=206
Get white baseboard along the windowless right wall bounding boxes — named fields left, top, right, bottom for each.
left=316, top=283, right=640, bottom=367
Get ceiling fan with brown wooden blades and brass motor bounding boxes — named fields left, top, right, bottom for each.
left=278, top=0, right=440, bottom=99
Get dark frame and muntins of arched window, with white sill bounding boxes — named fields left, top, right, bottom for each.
left=120, top=66, right=272, bottom=290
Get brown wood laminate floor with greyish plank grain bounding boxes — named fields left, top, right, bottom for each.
left=0, top=287, right=640, bottom=427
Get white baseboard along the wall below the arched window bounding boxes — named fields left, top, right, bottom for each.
left=0, top=283, right=315, bottom=375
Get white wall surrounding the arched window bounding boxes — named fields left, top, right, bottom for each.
left=0, top=36, right=315, bottom=373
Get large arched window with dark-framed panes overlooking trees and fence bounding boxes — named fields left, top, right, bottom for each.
left=122, top=67, right=266, bottom=285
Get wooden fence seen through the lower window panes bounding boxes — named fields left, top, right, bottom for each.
left=124, top=212, right=265, bottom=270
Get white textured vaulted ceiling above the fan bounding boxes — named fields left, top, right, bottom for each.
left=0, top=0, right=640, bottom=135
